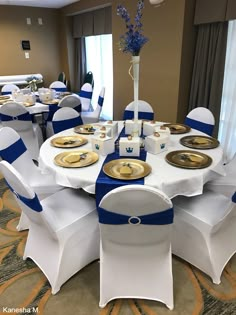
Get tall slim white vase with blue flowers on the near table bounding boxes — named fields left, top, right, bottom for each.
left=117, top=0, right=148, bottom=136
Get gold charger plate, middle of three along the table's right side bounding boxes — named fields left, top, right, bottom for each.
left=180, top=135, right=220, bottom=149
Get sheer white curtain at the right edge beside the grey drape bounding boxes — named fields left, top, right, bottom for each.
left=218, top=20, right=236, bottom=163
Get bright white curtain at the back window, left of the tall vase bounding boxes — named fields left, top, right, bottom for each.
left=85, top=34, right=113, bottom=120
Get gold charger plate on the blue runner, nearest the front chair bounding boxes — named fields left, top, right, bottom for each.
left=103, top=159, right=152, bottom=180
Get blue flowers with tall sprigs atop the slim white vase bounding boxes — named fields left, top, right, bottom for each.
left=117, top=0, right=148, bottom=56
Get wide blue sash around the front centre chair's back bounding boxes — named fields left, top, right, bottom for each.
left=98, top=207, right=174, bottom=225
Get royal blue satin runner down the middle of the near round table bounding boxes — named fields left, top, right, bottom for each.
left=95, top=128, right=147, bottom=207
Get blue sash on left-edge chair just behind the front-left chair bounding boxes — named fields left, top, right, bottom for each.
left=0, top=138, right=27, bottom=167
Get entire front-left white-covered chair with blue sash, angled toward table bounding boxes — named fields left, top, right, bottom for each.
left=0, top=161, right=99, bottom=294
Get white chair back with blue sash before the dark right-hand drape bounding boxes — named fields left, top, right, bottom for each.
left=184, top=107, right=215, bottom=136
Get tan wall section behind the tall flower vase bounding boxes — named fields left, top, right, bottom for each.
left=63, top=0, right=195, bottom=122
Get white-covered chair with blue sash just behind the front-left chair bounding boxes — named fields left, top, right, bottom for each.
left=0, top=127, right=63, bottom=231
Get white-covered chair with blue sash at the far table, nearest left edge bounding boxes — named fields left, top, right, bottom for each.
left=0, top=102, right=43, bottom=161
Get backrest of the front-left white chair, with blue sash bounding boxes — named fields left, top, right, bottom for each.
left=0, top=161, right=43, bottom=224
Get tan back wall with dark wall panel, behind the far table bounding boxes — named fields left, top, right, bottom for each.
left=0, top=6, right=63, bottom=86
